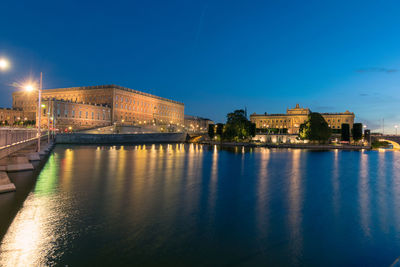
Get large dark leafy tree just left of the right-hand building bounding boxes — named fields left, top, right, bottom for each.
left=223, top=109, right=256, bottom=141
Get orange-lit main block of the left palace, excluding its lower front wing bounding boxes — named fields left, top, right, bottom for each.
left=13, top=85, right=184, bottom=129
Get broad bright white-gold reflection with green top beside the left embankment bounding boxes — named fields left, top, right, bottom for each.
left=0, top=157, right=65, bottom=266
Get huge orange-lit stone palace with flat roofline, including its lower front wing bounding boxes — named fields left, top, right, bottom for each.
left=12, top=85, right=184, bottom=129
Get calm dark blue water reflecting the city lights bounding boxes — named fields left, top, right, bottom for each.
left=0, top=145, right=400, bottom=266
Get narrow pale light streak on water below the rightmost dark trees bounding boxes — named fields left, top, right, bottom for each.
left=358, top=153, right=371, bottom=237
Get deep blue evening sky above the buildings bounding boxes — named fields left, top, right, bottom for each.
left=0, top=0, right=400, bottom=131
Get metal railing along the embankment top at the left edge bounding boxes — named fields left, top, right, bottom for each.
left=0, top=128, right=38, bottom=149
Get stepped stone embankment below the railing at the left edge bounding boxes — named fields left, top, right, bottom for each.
left=0, top=138, right=55, bottom=193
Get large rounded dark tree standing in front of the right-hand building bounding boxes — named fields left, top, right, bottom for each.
left=299, top=112, right=331, bottom=142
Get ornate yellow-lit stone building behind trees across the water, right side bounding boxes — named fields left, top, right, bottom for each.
left=250, top=104, right=354, bottom=134
